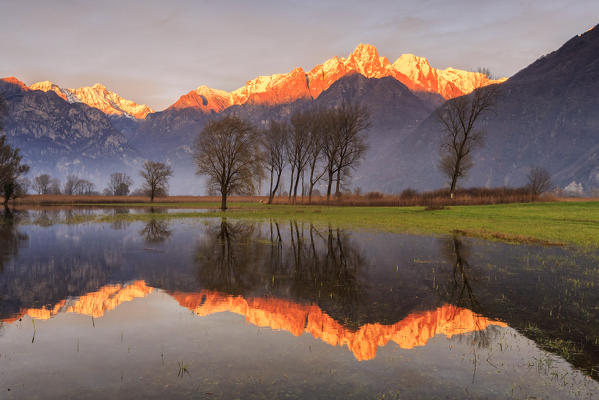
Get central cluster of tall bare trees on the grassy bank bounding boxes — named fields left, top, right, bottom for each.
left=193, top=103, right=370, bottom=210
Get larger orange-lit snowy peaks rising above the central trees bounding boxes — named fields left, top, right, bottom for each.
left=169, top=44, right=506, bottom=112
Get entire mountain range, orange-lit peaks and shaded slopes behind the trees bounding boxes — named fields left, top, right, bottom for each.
left=0, top=25, right=599, bottom=194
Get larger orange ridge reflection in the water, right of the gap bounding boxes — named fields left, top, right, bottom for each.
left=171, top=291, right=507, bottom=361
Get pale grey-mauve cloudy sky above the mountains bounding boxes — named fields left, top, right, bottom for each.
left=0, top=0, right=599, bottom=110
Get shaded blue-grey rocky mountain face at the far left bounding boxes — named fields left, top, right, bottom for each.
left=0, top=78, right=138, bottom=181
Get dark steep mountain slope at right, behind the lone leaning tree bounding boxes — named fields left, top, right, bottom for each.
left=392, top=27, right=599, bottom=190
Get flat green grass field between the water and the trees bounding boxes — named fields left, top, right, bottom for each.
left=86, top=201, right=599, bottom=247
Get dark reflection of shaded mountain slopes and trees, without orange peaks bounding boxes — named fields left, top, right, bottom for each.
left=0, top=212, right=599, bottom=378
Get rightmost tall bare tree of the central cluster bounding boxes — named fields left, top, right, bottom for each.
left=321, top=103, right=370, bottom=200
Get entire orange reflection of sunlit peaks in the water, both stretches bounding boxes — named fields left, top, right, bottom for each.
left=0, top=281, right=506, bottom=361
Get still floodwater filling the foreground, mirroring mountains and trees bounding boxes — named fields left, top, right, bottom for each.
left=0, top=208, right=599, bottom=399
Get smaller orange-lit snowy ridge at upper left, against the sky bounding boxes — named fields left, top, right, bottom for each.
left=29, top=81, right=154, bottom=118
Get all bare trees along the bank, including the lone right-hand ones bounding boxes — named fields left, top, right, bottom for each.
left=0, top=85, right=552, bottom=210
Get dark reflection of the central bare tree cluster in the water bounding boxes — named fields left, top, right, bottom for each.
left=196, top=220, right=365, bottom=316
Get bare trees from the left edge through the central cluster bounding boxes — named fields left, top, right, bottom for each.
left=0, top=90, right=370, bottom=210
